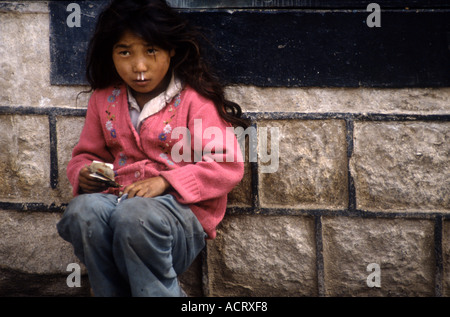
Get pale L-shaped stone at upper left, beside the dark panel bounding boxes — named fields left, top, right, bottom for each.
left=0, top=8, right=89, bottom=107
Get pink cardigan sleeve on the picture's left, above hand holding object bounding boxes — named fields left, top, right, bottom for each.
left=67, top=91, right=113, bottom=196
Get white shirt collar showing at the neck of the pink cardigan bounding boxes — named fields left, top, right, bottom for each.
left=127, top=75, right=182, bottom=134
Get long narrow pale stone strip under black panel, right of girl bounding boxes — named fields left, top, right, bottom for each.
left=226, top=86, right=450, bottom=114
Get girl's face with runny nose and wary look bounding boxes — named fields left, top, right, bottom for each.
left=112, top=31, right=175, bottom=103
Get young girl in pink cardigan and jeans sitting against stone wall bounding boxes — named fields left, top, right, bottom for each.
left=57, top=0, right=245, bottom=296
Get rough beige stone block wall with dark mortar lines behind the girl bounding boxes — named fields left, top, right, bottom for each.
left=0, top=1, right=450, bottom=296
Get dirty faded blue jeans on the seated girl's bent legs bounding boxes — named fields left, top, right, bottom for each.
left=57, top=194, right=206, bottom=296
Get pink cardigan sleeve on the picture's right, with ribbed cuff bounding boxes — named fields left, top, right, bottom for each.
left=160, top=103, right=244, bottom=204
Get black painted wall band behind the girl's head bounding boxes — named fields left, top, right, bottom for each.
left=49, top=1, right=450, bottom=87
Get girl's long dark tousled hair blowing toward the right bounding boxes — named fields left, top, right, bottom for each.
left=86, top=0, right=248, bottom=127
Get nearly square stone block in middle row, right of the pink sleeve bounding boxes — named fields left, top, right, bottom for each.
left=258, top=120, right=348, bottom=209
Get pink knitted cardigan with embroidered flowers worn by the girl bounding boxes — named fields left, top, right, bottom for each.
left=67, top=86, right=244, bottom=239
